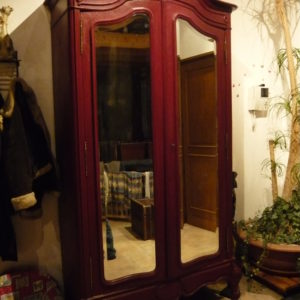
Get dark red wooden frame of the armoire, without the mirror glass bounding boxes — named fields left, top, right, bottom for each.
left=45, top=0, right=241, bottom=300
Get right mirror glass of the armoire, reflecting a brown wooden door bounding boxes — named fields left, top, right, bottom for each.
left=176, top=19, right=219, bottom=263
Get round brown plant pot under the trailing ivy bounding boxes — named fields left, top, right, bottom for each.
left=237, top=229, right=300, bottom=277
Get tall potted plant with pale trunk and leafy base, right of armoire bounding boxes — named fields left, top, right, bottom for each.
left=237, top=0, right=300, bottom=276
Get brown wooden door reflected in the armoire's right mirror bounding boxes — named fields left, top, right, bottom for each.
left=180, top=53, right=218, bottom=231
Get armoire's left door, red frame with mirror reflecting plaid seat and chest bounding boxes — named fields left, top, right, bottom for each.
left=87, top=1, right=165, bottom=285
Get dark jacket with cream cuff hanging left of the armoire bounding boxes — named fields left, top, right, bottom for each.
left=0, top=78, right=57, bottom=256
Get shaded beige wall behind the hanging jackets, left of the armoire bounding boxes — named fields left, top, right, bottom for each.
left=0, top=0, right=62, bottom=285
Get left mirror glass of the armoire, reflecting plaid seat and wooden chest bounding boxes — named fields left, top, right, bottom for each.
left=95, top=14, right=155, bottom=280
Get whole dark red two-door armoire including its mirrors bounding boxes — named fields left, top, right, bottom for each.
left=45, top=0, right=241, bottom=300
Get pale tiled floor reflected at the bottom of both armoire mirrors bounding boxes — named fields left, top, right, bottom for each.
left=102, top=220, right=219, bottom=280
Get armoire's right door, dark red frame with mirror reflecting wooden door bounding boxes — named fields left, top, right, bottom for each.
left=163, top=1, right=231, bottom=276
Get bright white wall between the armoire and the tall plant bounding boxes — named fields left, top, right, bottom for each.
left=231, top=0, right=300, bottom=219
